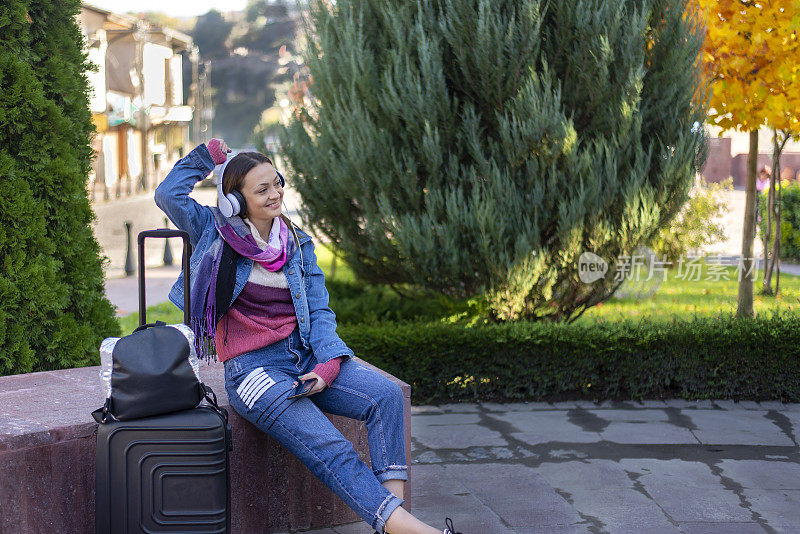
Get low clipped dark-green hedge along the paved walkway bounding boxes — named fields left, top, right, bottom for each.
left=338, top=312, right=800, bottom=404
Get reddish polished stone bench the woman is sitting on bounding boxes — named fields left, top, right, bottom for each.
left=0, top=359, right=411, bottom=534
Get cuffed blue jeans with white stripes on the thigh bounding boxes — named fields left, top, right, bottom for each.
left=224, top=328, right=408, bottom=532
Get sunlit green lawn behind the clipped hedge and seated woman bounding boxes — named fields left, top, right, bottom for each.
left=120, top=248, right=800, bottom=333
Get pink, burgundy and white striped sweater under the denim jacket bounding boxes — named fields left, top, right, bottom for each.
left=214, top=217, right=341, bottom=385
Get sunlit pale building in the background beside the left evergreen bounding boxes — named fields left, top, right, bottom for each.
left=78, top=3, right=210, bottom=201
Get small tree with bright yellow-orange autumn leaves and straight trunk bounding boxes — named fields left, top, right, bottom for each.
left=695, top=0, right=800, bottom=317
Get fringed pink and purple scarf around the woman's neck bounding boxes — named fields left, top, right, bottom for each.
left=190, top=207, right=295, bottom=360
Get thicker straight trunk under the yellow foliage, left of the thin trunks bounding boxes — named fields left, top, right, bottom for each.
left=736, top=130, right=758, bottom=317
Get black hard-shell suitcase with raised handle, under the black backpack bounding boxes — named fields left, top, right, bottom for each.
left=95, top=230, right=232, bottom=534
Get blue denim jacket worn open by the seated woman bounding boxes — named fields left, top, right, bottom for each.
left=155, top=143, right=354, bottom=363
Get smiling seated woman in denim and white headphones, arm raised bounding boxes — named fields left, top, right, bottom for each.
left=155, top=139, right=457, bottom=534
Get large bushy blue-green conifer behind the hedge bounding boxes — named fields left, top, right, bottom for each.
left=281, top=0, right=705, bottom=320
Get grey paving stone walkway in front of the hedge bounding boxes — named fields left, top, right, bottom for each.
left=288, top=400, right=800, bottom=534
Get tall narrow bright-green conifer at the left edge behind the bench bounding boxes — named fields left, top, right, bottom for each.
left=0, top=0, right=119, bottom=374
